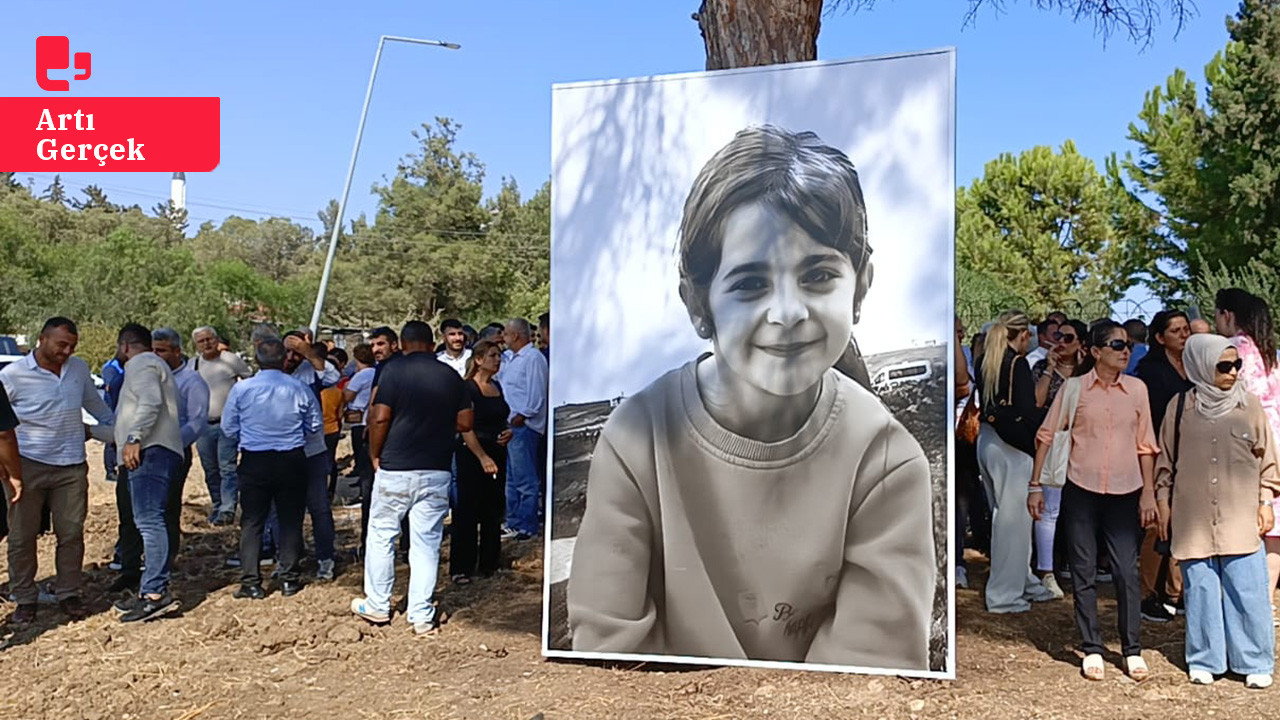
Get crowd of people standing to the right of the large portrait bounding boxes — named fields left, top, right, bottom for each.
left=955, top=288, right=1280, bottom=689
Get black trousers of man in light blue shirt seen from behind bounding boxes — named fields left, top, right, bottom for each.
left=237, top=447, right=307, bottom=584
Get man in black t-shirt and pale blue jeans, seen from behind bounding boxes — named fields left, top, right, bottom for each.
left=351, top=320, right=472, bottom=634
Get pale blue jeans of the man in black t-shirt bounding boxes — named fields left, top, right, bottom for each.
left=365, top=470, right=451, bottom=625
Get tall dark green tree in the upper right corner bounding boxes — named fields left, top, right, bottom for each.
left=1124, top=0, right=1280, bottom=299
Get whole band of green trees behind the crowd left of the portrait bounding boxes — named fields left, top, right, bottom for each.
left=0, top=118, right=550, bottom=368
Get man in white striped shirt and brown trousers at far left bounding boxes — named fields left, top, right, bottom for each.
left=0, top=318, right=114, bottom=625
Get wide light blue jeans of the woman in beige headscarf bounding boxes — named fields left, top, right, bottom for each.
left=1180, top=547, right=1276, bottom=675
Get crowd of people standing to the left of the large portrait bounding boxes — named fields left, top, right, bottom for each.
left=0, top=314, right=550, bottom=634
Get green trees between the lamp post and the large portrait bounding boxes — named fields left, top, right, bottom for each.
left=323, top=118, right=550, bottom=327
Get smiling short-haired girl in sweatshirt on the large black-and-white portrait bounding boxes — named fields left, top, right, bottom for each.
left=568, top=127, right=946, bottom=670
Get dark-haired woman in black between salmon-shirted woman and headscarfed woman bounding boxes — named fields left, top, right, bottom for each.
left=1135, top=310, right=1192, bottom=623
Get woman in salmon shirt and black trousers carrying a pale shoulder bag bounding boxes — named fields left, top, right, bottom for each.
left=1027, top=320, right=1160, bottom=682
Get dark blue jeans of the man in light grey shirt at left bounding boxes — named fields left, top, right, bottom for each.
left=129, top=446, right=182, bottom=594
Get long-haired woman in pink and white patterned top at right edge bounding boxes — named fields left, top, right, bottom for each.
left=1213, top=287, right=1280, bottom=609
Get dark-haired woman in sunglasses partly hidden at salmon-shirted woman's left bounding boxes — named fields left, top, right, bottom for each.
left=1032, top=320, right=1088, bottom=600
